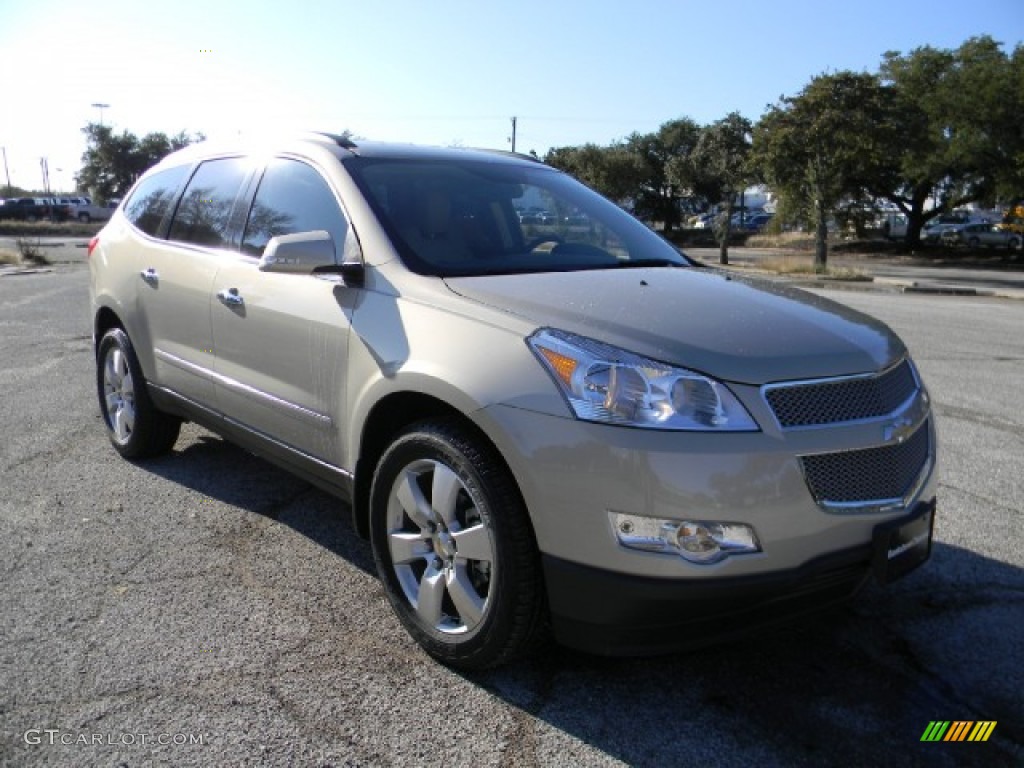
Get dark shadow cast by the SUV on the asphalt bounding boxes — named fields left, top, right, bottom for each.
left=140, top=435, right=1024, bottom=767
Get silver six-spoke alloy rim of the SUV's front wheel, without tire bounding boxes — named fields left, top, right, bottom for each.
left=387, top=459, right=497, bottom=635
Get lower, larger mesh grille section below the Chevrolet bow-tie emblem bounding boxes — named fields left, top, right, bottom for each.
left=800, top=420, right=931, bottom=504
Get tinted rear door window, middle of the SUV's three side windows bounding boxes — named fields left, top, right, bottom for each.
left=168, top=158, right=251, bottom=248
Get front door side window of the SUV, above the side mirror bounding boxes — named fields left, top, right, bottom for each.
left=242, top=158, right=348, bottom=256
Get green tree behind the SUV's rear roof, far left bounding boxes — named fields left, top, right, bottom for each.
left=76, top=123, right=204, bottom=203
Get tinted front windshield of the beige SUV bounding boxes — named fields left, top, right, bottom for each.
left=345, top=158, right=690, bottom=276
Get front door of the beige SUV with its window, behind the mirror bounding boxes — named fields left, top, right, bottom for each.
left=212, top=158, right=355, bottom=464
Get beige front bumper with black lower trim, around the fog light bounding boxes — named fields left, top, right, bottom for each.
left=478, top=407, right=937, bottom=654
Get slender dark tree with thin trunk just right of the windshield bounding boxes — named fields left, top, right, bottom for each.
left=684, top=112, right=753, bottom=264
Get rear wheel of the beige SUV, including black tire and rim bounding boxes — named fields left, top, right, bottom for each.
left=96, top=328, right=181, bottom=459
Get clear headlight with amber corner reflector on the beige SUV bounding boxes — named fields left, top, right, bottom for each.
left=527, top=329, right=758, bottom=432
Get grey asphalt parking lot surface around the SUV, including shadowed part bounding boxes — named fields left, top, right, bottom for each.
left=0, top=263, right=1024, bottom=766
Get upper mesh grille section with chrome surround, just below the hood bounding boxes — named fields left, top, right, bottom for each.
left=765, top=359, right=918, bottom=428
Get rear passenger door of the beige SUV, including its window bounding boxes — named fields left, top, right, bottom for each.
left=134, top=158, right=253, bottom=408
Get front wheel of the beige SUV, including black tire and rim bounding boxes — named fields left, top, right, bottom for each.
left=370, top=420, right=547, bottom=671
